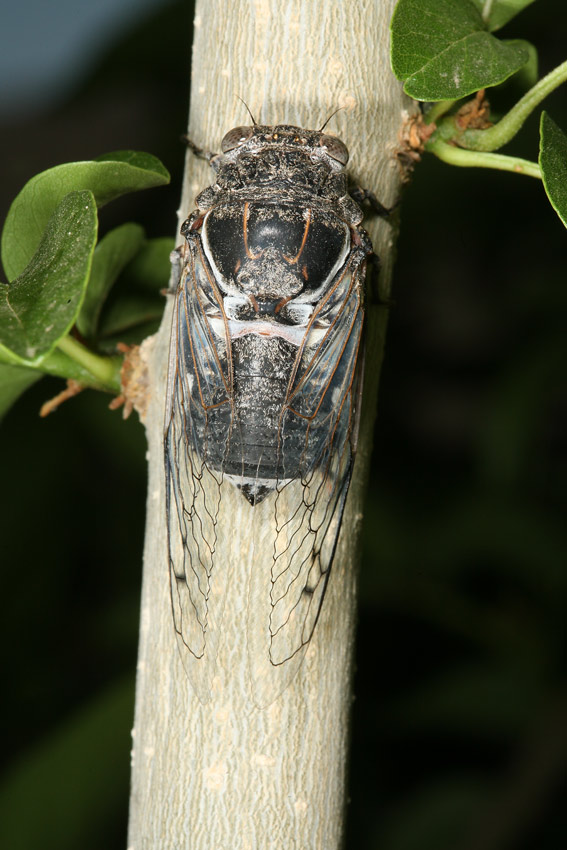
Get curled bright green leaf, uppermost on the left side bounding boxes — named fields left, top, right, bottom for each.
left=2, top=151, right=169, bottom=281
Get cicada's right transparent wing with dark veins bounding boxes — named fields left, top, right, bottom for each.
left=249, top=259, right=365, bottom=706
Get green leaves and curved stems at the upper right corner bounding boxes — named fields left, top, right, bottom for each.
left=391, top=0, right=567, bottom=224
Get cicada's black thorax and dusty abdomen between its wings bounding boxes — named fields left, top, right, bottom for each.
left=195, top=195, right=351, bottom=504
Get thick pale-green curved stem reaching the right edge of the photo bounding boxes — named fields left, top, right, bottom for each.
left=460, top=61, right=567, bottom=151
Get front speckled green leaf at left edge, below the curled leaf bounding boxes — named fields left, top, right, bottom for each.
left=0, top=191, right=98, bottom=363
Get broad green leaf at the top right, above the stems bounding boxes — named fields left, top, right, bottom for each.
left=391, top=0, right=528, bottom=101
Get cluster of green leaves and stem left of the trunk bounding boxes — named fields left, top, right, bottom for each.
left=0, top=151, right=173, bottom=415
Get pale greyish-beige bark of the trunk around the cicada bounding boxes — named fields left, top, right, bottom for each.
left=129, top=0, right=412, bottom=850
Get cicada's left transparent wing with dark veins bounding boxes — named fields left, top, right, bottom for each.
left=165, top=240, right=232, bottom=702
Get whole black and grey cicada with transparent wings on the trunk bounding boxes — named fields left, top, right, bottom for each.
left=164, top=119, right=372, bottom=705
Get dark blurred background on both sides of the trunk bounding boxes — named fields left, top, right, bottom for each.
left=0, top=0, right=567, bottom=850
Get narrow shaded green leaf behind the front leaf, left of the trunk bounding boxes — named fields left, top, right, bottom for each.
left=77, top=223, right=144, bottom=339
